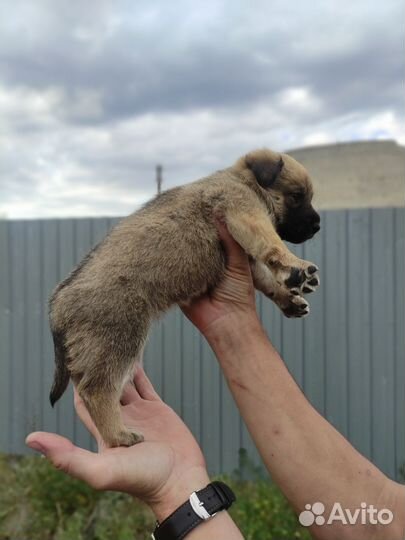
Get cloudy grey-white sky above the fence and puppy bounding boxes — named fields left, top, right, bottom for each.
left=0, top=0, right=405, bottom=218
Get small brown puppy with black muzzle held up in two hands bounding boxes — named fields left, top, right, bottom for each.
left=50, top=150, right=319, bottom=446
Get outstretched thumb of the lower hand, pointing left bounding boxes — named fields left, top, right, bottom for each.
left=25, top=431, right=104, bottom=489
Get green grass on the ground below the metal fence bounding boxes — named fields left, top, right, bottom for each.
left=0, top=455, right=311, bottom=540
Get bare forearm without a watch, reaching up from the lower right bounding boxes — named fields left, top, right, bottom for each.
left=206, top=318, right=405, bottom=540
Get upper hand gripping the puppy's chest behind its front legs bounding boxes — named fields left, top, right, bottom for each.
left=182, top=220, right=257, bottom=337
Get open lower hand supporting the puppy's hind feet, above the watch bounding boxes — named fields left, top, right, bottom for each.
left=26, top=367, right=209, bottom=521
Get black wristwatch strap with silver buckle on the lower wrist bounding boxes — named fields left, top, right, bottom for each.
left=152, top=481, right=235, bottom=540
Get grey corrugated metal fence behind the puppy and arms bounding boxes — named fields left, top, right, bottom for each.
left=0, top=209, right=405, bottom=478
